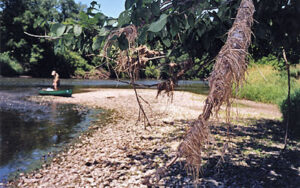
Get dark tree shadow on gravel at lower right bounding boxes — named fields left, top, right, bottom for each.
left=144, top=119, right=300, bottom=188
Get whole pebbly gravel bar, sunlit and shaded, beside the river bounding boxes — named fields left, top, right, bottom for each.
left=9, top=89, right=300, bottom=187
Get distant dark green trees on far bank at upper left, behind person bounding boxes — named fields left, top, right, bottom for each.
left=0, top=0, right=89, bottom=77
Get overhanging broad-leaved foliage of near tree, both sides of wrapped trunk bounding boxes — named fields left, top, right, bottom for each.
left=47, top=0, right=300, bottom=79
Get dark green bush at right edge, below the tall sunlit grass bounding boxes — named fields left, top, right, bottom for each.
left=280, top=89, right=300, bottom=137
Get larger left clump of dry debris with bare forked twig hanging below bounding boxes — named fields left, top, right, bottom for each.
left=103, top=25, right=165, bottom=128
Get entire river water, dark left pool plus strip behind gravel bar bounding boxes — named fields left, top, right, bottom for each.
left=0, top=78, right=208, bottom=182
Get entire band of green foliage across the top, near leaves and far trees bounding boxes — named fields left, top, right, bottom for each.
left=0, top=0, right=300, bottom=79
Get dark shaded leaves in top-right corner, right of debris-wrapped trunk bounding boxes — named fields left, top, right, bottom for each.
left=251, top=0, right=300, bottom=64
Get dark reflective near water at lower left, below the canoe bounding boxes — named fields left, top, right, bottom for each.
left=0, top=89, right=100, bottom=182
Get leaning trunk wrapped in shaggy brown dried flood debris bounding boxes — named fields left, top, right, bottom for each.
left=145, top=0, right=255, bottom=184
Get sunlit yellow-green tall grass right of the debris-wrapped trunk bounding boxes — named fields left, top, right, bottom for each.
left=237, top=64, right=299, bottom=104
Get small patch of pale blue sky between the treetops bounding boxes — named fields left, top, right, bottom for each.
left=75, top=0, right=125, bottom=18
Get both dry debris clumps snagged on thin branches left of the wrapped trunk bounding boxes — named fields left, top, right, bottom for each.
left=103, top=25, right=193, bottom=126
